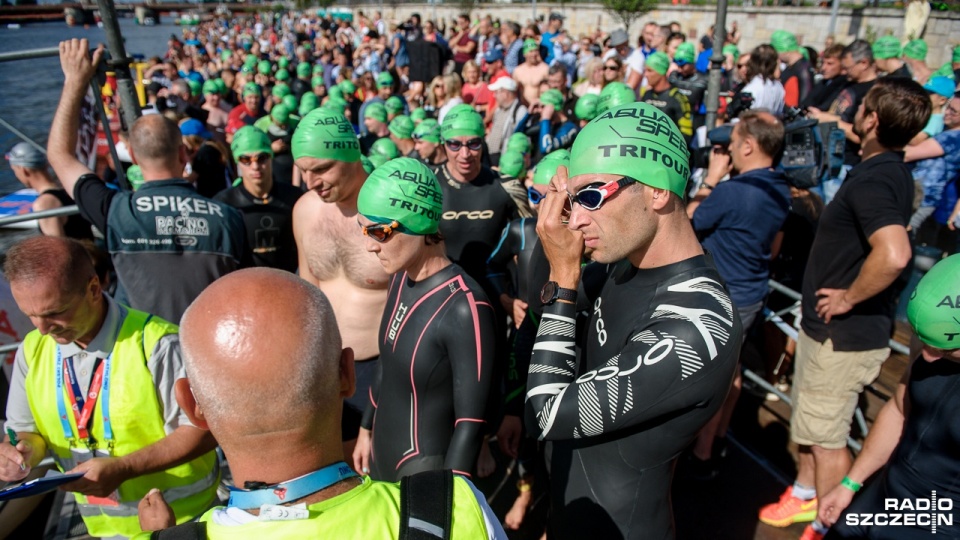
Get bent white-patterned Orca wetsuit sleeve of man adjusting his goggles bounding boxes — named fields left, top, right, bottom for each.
left=526, top=302, right=740, bottom=440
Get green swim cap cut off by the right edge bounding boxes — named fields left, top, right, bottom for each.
left=907, top=254, right=960, bottom=351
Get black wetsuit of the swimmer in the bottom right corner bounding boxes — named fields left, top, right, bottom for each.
left=827, top=356, right=960, bottom=540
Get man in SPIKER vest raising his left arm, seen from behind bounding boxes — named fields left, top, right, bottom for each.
left=47, top=39, right=252, bottom=322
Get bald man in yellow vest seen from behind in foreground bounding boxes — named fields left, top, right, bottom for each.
left=141, top=268, right=503, bottom=539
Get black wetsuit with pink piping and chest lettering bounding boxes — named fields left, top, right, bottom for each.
left=362, top=264, right=496, bottom=482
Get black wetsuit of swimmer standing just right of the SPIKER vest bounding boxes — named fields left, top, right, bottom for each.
left=214, top=182, right=303, bottom=272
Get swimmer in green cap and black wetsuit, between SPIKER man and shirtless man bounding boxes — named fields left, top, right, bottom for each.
left=213, top=125, right=303, bottom=272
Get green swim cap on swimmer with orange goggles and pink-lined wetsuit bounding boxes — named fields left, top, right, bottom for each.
left=357, top=158, right=443, bottom=235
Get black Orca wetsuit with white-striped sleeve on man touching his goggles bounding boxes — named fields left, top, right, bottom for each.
left=526, top=256, right=742, bottom=539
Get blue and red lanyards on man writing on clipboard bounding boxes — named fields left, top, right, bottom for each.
left=56, top=346, right=113, bottom=448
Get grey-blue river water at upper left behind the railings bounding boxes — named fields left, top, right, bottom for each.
left=0, top=17, right=180, bottom=195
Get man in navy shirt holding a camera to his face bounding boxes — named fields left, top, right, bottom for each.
left=687, top=109, right=790, bottom=479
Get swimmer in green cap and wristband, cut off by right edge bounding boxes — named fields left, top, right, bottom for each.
left=818, top=255, right=960, bottom=539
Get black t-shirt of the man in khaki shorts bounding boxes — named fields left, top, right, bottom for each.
left=802, top=152, right=914, bottom=351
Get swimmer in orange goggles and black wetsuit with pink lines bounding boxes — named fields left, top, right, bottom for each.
left=353, top=158, right=497, bottom=482
